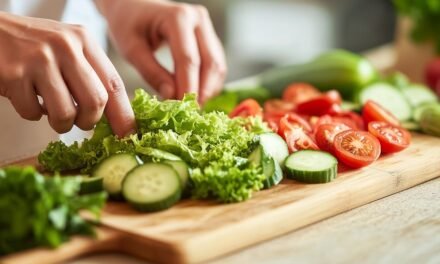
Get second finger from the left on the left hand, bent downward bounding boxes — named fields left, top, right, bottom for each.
left=34, top=64, right=76, bottom=134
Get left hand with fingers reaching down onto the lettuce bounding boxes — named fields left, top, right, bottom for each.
left=0, top=12, right=135, bottom=136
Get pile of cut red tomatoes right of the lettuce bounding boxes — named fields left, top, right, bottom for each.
left=230, top=83, right=411, bottom=170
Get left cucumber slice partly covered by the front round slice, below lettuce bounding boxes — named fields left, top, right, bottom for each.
left=92, top=153, right=142, bottom=198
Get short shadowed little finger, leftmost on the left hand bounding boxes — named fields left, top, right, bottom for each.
left=10, top=83, right=43, bottom=121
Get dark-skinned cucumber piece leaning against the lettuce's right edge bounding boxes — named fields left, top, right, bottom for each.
left=249, top=145, right=283, bottom=189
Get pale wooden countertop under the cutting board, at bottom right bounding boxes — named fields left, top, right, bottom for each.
left=68, top=46, right=440, bottom=264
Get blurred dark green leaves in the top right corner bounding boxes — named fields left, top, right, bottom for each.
left=393, top=0, right=440, bottom=53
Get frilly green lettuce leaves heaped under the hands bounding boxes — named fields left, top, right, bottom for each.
left=39, top=89, right=269, bottom=202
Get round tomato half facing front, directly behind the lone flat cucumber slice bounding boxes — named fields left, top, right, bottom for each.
left=333, top=130, right=380, bottom=168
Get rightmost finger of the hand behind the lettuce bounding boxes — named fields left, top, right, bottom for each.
left=196, top=8, right=226, bottom=102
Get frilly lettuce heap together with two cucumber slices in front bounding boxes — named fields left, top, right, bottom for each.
left=39, top=89, right=269, bottom=211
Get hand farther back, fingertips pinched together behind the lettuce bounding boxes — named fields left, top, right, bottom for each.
left=95, top=0, right=226, bottom=102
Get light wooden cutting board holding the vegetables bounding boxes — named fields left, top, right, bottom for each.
left=0, top=134, right=440, bottom=264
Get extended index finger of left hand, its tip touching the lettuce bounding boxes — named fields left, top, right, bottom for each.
left=80, top=27, right=136, bottom=137
